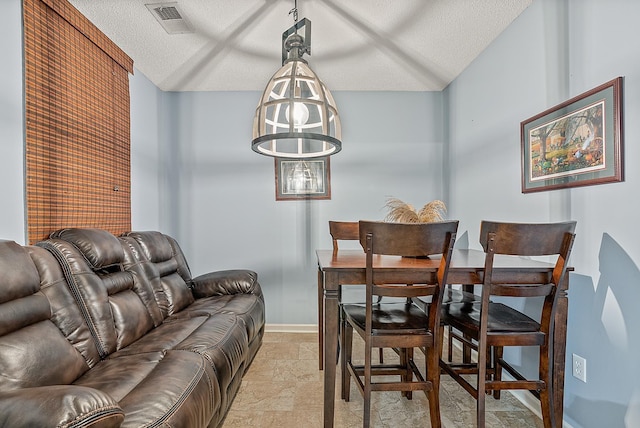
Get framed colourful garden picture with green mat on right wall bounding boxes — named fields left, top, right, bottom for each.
left=520, top=77, right=623, bottom=193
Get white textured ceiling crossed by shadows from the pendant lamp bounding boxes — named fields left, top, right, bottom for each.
left=70, top=0, right=532, bottom=91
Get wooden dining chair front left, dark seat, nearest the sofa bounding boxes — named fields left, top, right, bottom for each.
left=340, top=221, right=458, bottom=427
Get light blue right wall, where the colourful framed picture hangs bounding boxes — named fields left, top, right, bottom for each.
left=444, top=0, right=640, bottom=428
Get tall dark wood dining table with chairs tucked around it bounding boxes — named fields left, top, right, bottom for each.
left=316, top=250, right=569, bottom=427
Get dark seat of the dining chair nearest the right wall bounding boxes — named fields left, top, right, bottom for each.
left=442, top=302, right=540, bottom=333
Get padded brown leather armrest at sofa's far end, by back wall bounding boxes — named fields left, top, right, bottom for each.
left=191, top=269, right=262, bottom=299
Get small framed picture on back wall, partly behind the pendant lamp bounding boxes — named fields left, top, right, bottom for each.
left=275, top=157, right=331, bottom=201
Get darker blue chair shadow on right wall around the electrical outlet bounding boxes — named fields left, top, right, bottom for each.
left=565, top=233, right=640, bottom=428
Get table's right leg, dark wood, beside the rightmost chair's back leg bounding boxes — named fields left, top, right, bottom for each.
left=551, top=272, right=569, bottom=426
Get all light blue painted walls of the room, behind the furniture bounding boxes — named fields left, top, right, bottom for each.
left=0, top=0, right=640, bottom=422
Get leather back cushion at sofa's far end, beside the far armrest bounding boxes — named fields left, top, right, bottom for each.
left=121, top=231, right=194, bottom=318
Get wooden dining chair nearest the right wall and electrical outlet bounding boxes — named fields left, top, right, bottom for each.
left=440, top=221, right=576, bottom=428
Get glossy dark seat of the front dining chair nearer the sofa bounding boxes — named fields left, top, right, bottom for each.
left=343, top=302, right=429, bottom=335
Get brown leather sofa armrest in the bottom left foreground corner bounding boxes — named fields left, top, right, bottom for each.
left=0, top=385, right=124, bottom=428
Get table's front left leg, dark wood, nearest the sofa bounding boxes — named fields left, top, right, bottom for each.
left=324, top=272, right=339, bottom=428
